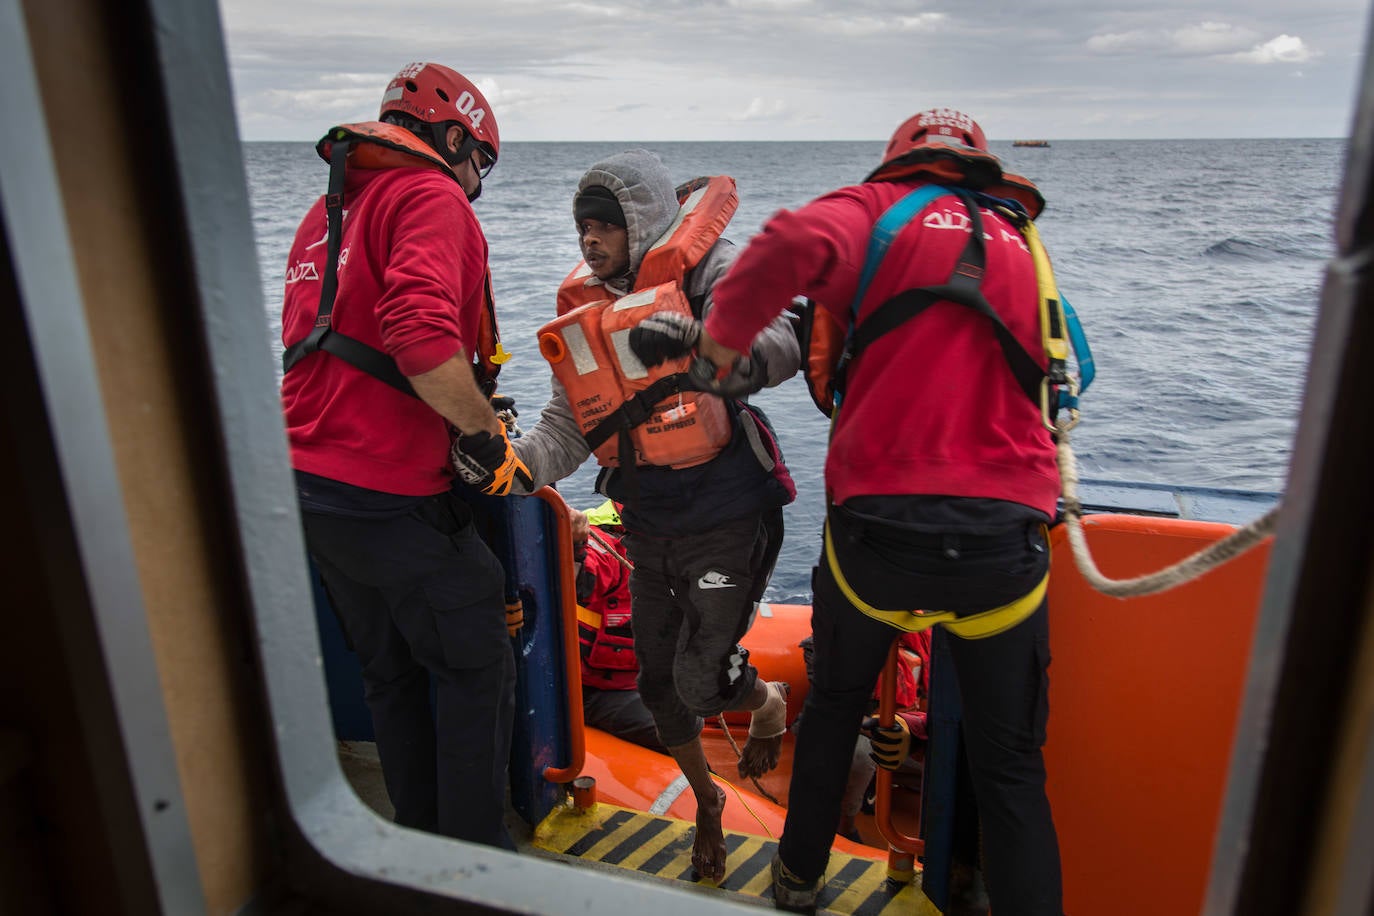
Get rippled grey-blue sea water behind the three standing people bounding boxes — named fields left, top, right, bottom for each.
left=245, top=139, right=1345, bottom=603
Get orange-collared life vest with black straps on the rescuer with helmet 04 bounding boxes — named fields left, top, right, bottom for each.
left=282, top=121, right=510, bottom=394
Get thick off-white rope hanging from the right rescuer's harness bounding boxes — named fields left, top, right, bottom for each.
left=1055, top=419, right=1279, bottom=597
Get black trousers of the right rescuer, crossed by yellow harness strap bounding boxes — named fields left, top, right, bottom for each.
left=778, top=515, right=1062, bottom=916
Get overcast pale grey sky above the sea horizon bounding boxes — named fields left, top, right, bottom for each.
left=221, top=0, right=1369, bottom=141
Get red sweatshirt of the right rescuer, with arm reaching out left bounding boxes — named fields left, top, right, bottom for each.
left=706, top=181, right=1059, bottom=518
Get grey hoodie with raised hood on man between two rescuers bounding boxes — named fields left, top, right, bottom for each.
left=513, top=150, right=801, bottom=492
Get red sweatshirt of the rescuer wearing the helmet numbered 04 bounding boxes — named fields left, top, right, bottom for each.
left=282, top=168, right=486, bottom=496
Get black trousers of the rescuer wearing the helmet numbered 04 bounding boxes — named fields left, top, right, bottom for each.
left=302, top=493, right=515, bottom=849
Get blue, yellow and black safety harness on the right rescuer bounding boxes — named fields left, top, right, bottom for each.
left=809, top=184, right=1094, bottom=639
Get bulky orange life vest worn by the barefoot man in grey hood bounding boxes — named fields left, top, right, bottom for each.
left=539, top=176, right=739, bottom=468
